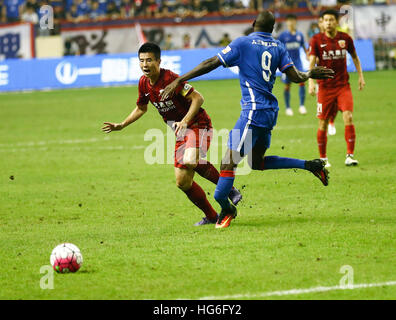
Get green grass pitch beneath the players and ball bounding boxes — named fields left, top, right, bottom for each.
left=0, top=71, right=396, bottom=299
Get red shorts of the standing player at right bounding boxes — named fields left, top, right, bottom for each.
left=316, top=84, right=353, bottom=120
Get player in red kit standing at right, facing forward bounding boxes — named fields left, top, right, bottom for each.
left=309, top=9, right=365, bottom=167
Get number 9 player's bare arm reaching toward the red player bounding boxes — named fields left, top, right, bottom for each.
left=160, top=56, right=221, bottom=100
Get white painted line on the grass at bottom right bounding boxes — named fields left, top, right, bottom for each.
left=189, top=281, right=396, bottom=300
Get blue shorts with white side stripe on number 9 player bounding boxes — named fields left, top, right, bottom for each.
left=227, top=109, right=278, bottom=157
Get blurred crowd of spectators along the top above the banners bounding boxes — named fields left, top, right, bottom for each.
left=0, top=0, right=396, bottom=24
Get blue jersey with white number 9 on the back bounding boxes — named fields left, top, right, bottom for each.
left=218, top=32, right=293, bottom=112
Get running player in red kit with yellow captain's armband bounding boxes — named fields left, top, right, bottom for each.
left=102, top=43, right=242, bottom=226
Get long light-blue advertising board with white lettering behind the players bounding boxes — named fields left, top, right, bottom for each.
left=0, top=40, right=375, bottom=92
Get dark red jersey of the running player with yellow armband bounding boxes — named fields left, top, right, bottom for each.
left=136, top=68, right=210, bottom=125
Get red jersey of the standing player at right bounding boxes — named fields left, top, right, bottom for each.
left=309, top=31, right=355, bottom=88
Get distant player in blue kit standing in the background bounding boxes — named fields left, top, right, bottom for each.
left=278, top=14, right=307, bottom=116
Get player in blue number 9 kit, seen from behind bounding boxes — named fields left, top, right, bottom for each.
left=162, top=11, right=334, bottom=228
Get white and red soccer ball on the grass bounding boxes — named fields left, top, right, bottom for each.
left=50, top=243, right=83, bottom=273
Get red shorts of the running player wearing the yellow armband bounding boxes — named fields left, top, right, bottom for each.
left=175, top=118, right=213, bottom=169
